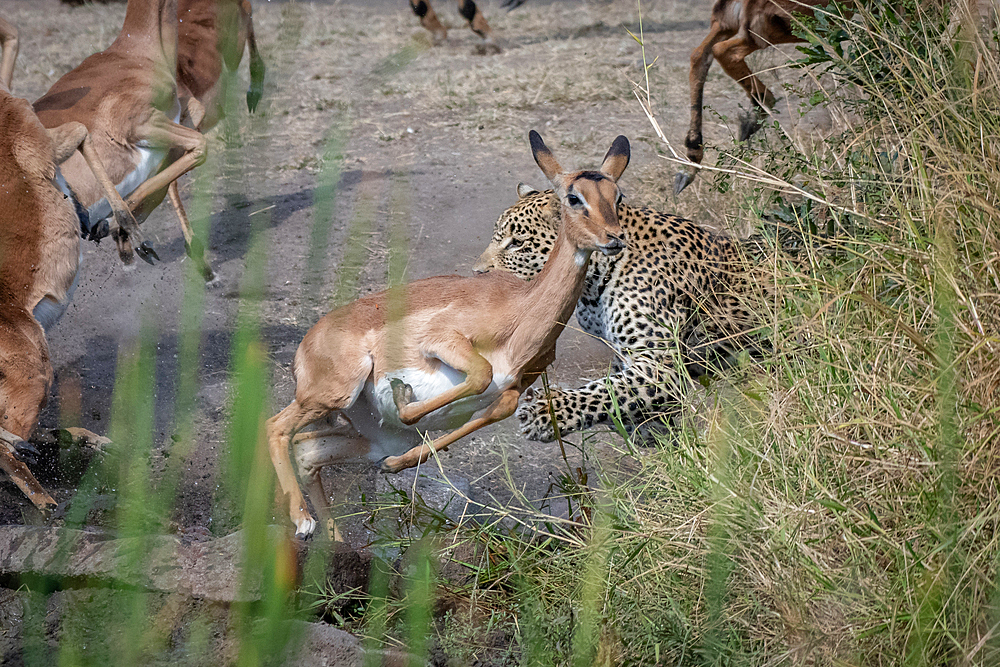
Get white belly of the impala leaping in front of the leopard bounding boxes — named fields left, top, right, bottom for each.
left=343, top=364, right=513, bottom=461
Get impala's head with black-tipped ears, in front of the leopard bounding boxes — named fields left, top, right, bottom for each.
left=528, top=130, right=630, bottom=255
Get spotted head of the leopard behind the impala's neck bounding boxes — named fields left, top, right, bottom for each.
left=473, top=183, right=561, bottom=280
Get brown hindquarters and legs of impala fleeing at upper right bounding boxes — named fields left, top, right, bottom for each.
left=674, top=0, right=848, bottom=193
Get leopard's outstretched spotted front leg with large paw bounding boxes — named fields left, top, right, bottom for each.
left=515, top=359, right=682, bottom=442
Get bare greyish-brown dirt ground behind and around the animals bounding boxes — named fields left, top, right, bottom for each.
left=0, top=0, right=816, bottom=543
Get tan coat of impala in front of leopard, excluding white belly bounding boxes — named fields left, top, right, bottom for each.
left=268, top=132, right=629, bottom=535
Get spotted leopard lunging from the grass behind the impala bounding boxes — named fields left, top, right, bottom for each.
left=474, top=183, right=765, bottom=442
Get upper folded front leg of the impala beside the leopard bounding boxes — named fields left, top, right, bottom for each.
left=390, top=335, right=493, bottom=426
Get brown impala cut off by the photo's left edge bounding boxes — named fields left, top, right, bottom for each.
left=0, top=19, right=144, bottom=509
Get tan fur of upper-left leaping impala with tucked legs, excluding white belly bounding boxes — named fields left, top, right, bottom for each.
left=34, top=0, right=205, bottom=261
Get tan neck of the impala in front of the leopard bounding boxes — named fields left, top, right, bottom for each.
left=518, top=218, right=593, bottom=349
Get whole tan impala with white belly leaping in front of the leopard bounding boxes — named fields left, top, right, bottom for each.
left=267, top=131, right=629, bottom=536
